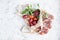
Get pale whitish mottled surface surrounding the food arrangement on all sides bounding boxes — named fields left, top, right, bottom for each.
left=0, top=0, right=60, bottom=40
